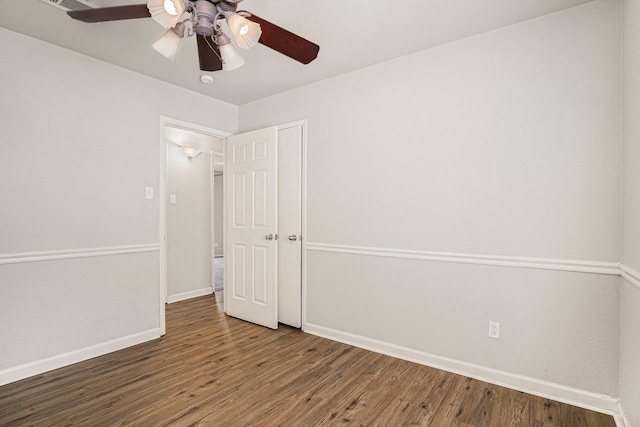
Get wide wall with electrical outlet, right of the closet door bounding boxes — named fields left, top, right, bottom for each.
left=239, top=0, right=622, bottom=406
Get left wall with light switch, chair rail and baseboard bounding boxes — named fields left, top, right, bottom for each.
left=0, top=28, right=237, bottom=384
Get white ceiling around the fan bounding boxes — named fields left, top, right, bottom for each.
left=0, top=0, right=592, bottom=105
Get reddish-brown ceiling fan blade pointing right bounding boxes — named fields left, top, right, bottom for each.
left=238, top=10, right=320, bottom=64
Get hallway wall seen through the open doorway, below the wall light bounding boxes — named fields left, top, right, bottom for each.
left=167, top=137, right=222, bottom=302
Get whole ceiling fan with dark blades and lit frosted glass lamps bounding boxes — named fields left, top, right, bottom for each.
left=67, top=0, right=320, bottom=71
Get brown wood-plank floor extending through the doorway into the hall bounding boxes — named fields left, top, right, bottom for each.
left=0, top=296, right=615, bottom=427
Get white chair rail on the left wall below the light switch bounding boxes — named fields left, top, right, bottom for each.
left=0, top=243, right=160, bottom=265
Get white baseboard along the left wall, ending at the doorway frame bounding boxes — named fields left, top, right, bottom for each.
left=0, top=328, right=161, bottom=386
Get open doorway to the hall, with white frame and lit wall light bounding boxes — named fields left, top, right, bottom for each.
left=159, top=117, right=229, bottom=332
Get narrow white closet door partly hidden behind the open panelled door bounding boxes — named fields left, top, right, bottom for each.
left=278, top=125, right=302, bottom=328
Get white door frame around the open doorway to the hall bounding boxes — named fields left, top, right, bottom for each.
left=158, top=116, right=232, bottom=335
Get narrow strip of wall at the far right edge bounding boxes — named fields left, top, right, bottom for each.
left=620, top=0, right=640, bottom=426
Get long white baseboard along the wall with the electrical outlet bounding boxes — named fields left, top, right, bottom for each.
left=304, top=322, right=619, bottom=417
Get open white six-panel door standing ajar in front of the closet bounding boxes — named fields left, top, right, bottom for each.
left=224, top=127, right=278, bottom=329
